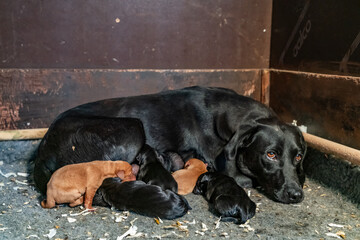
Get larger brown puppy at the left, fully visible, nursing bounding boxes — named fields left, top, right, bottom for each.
left=41, top=161, right=136, bottom=210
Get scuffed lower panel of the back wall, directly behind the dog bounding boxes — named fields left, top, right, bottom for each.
left=0, top=69, right=261, bottom=130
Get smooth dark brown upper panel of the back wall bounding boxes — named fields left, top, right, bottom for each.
left=0, top=0, right=272, bottom=69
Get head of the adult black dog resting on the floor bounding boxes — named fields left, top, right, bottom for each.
left=224, top=119, right=306, bottom=203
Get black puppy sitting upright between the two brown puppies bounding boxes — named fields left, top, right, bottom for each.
left=136, top=144, right=178, bottom=192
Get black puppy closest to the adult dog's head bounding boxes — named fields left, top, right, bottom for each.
left=193, top=172, right=256, bottom=224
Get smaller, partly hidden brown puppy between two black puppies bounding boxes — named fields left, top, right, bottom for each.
left=172, top=158, right=207, bottom=195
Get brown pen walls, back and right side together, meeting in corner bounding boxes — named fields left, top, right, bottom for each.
left=0, top=0, right=360, bottom=201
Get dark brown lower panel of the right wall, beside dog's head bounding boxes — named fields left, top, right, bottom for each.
left=270, top=70, right=360, bottom=149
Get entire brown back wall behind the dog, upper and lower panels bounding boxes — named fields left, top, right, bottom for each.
left=0, top=0, right=272, bottom=130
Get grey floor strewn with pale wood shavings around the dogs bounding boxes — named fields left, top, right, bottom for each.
left=0, top=141, right=360, bottom=240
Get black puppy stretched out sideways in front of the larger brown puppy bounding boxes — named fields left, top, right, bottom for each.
left=95, top=178, right=191, bottom=219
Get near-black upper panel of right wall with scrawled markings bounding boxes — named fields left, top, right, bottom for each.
left=270, top=0, right=360, bottom=76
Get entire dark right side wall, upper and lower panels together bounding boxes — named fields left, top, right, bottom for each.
left=270, top=0, right=360, bottom=149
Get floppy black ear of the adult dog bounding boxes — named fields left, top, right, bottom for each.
left=224, top=123, right=257, bottom=161
